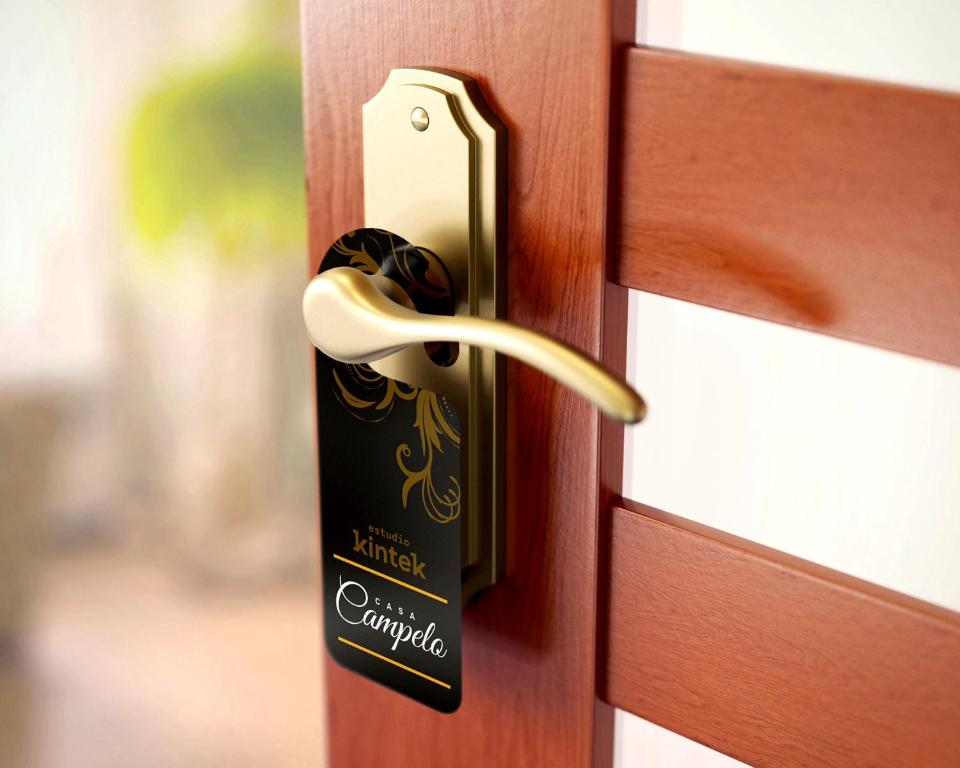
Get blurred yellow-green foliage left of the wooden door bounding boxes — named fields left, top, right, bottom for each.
left=129, top=45, right=305, bottom=264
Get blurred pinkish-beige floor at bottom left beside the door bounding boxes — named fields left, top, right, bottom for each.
left=0, top=553, right=325, bottom=768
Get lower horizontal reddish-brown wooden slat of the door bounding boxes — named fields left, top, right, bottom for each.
left=603, top=502, right=960, bottom=768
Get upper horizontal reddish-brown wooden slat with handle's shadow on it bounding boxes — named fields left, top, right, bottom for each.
left=618, top=48, right=960, bottom=364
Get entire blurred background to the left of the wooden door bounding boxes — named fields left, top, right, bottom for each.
left=0, top=0, right=324, bottom=768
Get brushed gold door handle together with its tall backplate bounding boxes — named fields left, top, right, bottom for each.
left=312, top=68, right=644, bottom=603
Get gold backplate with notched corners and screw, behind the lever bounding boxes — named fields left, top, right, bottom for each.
left=363, top=68, right=506, bottom=602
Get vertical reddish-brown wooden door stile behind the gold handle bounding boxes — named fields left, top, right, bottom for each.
left=303, top=0, right=633, bottom=768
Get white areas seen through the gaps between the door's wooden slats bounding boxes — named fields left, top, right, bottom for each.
left=616, top=0, right=960, bottom=768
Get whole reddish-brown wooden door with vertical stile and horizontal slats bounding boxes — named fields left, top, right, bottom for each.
left=303, top=0, right=960, bottom=767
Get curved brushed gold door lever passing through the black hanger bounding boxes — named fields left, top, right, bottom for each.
left=303, top=267, right=646, bottom=424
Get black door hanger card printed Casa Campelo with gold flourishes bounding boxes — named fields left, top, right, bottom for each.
left=316, top=229, right=461, bottom=712
